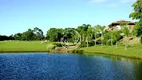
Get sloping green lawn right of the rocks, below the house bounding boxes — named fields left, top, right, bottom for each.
left=81, top=45, right=142, bottom=59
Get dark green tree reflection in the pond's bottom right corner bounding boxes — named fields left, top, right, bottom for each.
left=134, top=61, right=142, bottom=80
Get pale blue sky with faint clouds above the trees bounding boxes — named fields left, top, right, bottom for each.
left=0, top=0, right=136, bottom=35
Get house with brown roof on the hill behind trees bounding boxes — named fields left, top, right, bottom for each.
left=104, top=20, right=135, bottom=32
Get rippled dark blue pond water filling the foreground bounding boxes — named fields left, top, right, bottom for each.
left=0, top=53, right=142, bottom=80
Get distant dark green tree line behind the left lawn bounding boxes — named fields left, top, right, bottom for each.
left=0, top=27, right=44, bottom=41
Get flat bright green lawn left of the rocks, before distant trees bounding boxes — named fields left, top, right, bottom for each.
left=0, top=41, right=52, bottom=52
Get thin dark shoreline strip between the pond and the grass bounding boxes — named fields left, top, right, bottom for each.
left=0, top=51, right=142, bottom=60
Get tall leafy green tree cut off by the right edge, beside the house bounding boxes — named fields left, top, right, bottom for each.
left=129, top=0, right=142, bottom=43
